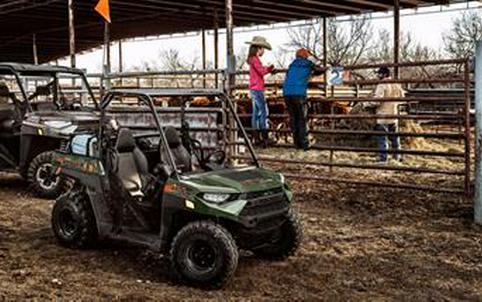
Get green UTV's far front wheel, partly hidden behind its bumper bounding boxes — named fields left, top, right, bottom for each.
left=253, top=211, right=303, bottom=260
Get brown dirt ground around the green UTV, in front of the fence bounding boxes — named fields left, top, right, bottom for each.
left=0, top=169, right=482, bottom=301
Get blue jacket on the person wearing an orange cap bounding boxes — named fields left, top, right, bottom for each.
left=283, top=58, right=315, bottom=97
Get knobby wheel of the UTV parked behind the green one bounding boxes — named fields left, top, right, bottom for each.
left=27, top=152, right=66, bottom=199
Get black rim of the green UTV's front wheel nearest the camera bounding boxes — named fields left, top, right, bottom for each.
left=187, top=240, right=217, bottom=274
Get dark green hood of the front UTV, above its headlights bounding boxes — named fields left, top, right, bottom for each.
left=182, top=167, right=283, bottom=193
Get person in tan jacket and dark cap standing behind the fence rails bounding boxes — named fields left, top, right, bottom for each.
left=373, top=67, right=405, bottom=163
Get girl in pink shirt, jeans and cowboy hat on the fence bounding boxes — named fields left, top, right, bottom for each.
left=246, top=37, right=274, bottom=147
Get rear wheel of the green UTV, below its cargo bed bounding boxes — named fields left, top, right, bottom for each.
left=52, top=188, right=97, bottom=248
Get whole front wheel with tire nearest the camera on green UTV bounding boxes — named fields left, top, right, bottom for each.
left=170, top=221, right=239, bottom=289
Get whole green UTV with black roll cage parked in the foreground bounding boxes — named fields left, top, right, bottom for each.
left=52, top=89, right=302, bottom=288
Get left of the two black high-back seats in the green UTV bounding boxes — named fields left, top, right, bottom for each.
left=116, top=128, right=149, bottom=197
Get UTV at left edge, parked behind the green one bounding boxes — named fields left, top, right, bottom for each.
left=0, top=63, right=99, bottom=198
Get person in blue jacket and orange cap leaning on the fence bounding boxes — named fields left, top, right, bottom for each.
left=283, top=48, right=324, bottom=150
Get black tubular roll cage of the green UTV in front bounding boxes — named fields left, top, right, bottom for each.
left=100, top=89, right=260, bottom=180
